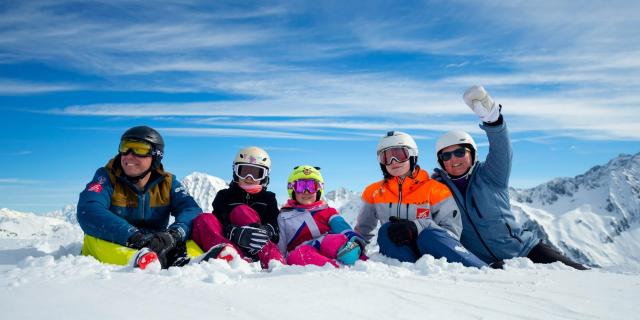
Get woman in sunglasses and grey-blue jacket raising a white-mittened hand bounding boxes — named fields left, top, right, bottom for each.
left=433, top=86, right=586, bottom=270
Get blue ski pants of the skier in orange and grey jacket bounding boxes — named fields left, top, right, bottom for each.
left=378, top=222, right=487, bottom=268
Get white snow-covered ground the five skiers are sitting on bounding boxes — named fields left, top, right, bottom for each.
left=0, top=209, right=640, bottom=319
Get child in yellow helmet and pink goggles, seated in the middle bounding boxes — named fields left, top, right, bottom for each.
left=278, top=165, right=366, bottom=267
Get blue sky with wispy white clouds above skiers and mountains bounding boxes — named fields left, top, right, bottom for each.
left=0, top=1, right=640, bottom=213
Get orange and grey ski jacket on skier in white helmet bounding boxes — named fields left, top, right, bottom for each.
left=354, top=166, right=462, bottom=240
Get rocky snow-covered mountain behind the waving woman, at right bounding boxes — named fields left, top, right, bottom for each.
left=511, top=153, right=640, bottom=266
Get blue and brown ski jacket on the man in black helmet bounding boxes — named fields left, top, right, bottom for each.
left=77, top=156, right=202, bottom=245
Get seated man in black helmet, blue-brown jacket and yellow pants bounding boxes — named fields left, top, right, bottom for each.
left=77, top=126, right=208, bottom=269
